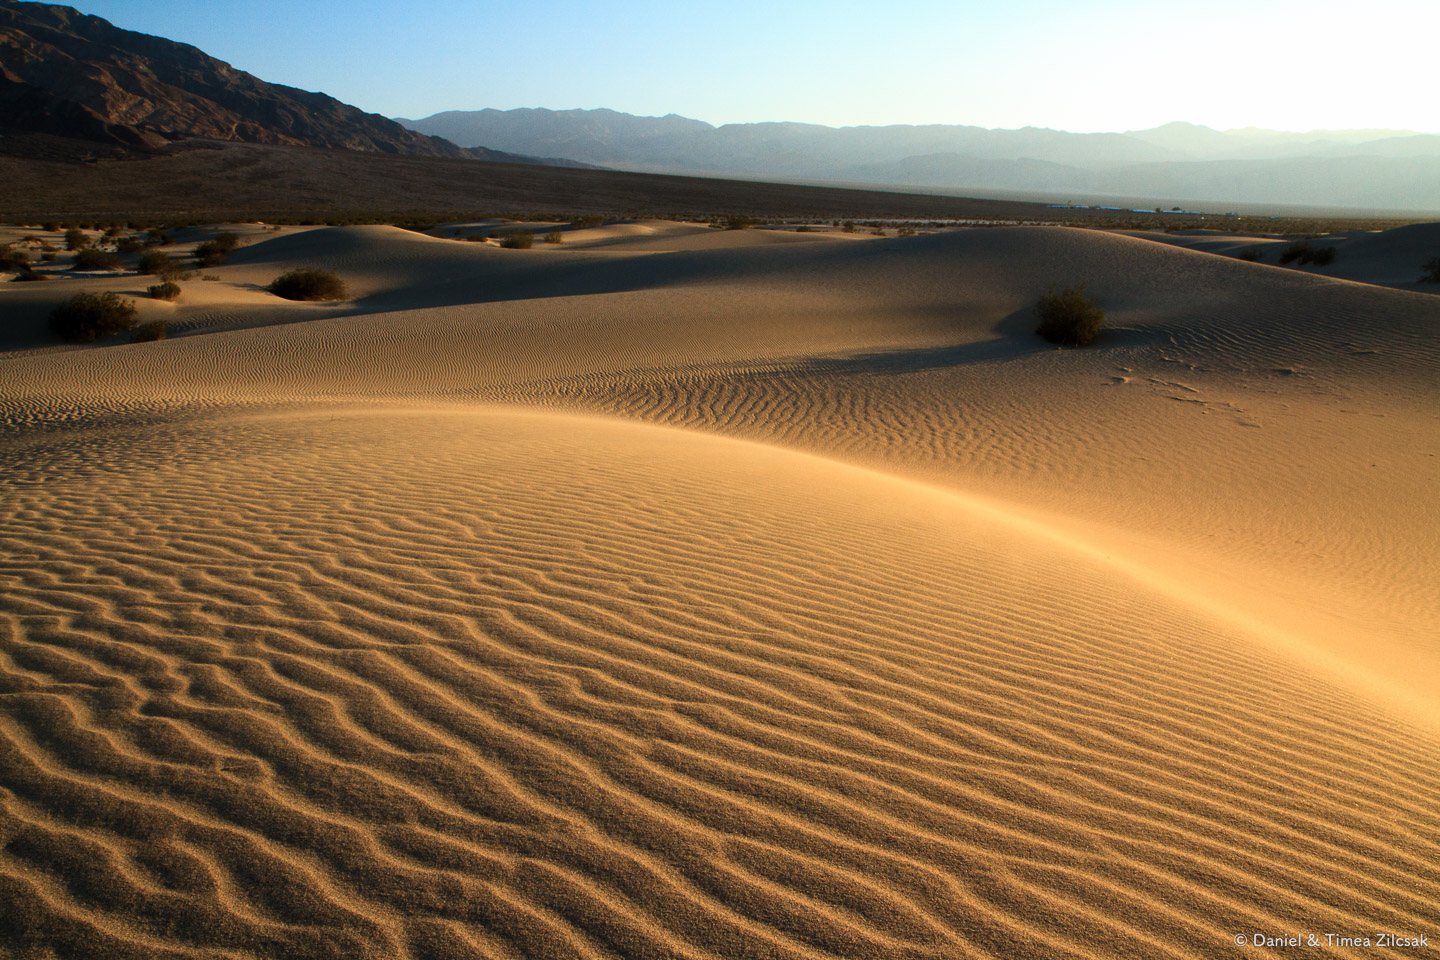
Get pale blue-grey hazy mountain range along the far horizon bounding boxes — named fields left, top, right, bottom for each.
left=400, top=109, right=1440, bottom=212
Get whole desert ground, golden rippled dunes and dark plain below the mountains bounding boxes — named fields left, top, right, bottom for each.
left=0, top=0, right=1440, bottom=960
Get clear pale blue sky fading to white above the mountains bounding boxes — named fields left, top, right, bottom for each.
left=71, top=0, right=1440, bottom=132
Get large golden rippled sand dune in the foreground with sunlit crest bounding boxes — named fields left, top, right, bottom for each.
left=0, top=408, right=1440, bottom=960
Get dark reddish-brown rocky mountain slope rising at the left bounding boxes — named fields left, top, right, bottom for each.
left=0, top=0, right=584, bottom=163
